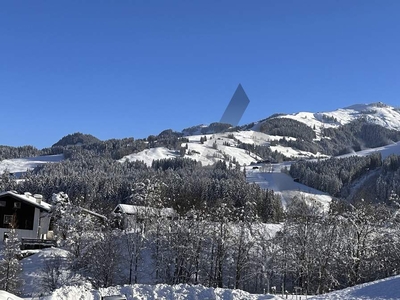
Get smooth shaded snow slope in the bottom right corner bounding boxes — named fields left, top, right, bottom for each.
left=308, top=276, right=400, bottom=300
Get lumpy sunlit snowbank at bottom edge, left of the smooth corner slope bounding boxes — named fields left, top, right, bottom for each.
left=44, top=284, right=282, bottom=300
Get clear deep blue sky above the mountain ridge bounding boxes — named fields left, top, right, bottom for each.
left=0, top=0, right=400, bottom=148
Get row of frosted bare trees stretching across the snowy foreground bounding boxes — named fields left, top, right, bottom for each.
left=0, top=192, right=400, bottom=295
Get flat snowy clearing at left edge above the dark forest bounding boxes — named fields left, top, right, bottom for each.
left=0, top=154, right=64, bottom=174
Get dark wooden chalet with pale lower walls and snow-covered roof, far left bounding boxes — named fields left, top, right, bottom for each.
left=0, top=191, right=51, bottom=240
